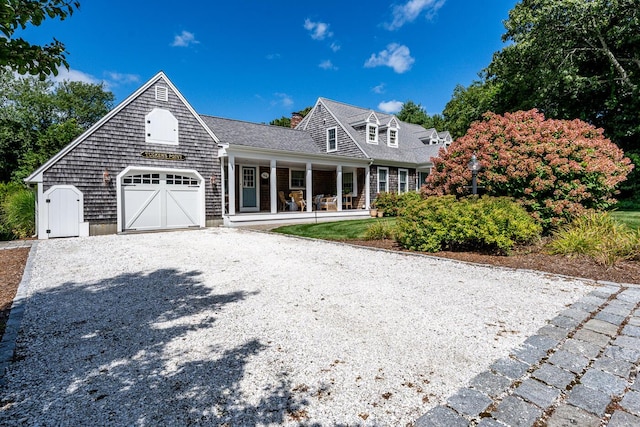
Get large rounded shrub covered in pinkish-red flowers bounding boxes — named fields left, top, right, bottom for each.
left=422, top=110, right=633, bottom=229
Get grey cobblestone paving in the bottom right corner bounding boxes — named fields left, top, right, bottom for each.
left=415, top=283, right=640, bottom=427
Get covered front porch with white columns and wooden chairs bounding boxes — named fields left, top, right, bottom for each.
left=220, top=147, right=371, bottom=226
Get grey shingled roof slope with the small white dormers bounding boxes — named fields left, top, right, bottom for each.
left=314, top=98, right=444, bottom=164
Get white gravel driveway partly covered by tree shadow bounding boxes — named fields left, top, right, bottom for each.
left=0, top=228, right=592, bottom=426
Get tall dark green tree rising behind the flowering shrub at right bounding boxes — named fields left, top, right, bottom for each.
left=487, top=0, right=640, bottom=149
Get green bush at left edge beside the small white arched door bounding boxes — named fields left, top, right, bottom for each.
left=0, top=184, right=36, bottom=240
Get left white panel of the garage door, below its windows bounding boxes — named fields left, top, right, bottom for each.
left=124, top=187, right=162, bottom=230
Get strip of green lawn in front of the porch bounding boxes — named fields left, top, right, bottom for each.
left=272, top=218, right=396, bottom=240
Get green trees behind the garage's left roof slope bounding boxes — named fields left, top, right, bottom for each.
left=0, top=70, right=114, bottom=181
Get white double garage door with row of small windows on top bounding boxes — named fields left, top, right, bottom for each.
left=122, top=172, right=203, bottom=230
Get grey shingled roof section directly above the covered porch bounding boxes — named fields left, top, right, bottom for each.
left=200, top=115, right=322, bottom=154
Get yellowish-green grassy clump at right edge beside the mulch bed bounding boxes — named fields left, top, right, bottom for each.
left=548, top=212, right=640, bottom=266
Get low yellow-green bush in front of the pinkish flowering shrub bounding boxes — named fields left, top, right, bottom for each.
left=396, top=196, right=542, bottom=254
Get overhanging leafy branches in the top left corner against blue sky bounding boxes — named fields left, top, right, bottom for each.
left=0, top=0, right=80, bottom=80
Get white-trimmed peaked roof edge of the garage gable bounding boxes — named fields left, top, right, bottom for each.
left=24, top=71, right=220, bottom=183
